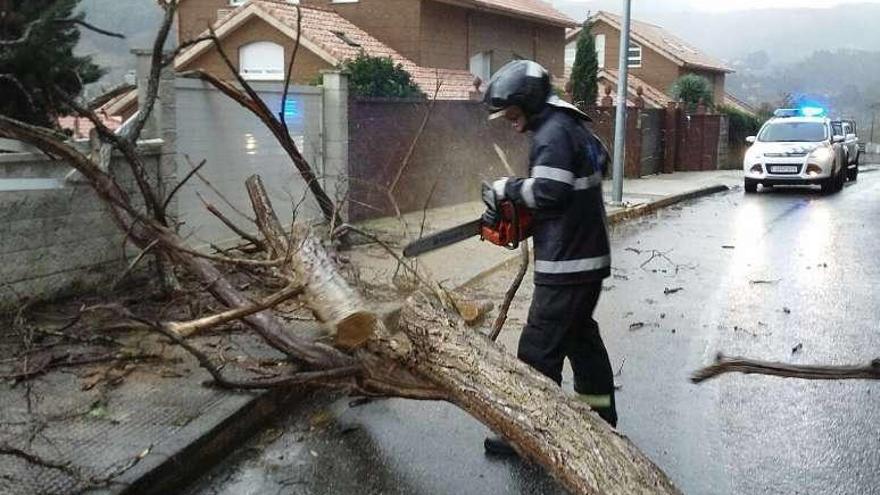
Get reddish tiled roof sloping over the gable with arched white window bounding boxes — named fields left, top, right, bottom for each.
left=175, top=0, right=478, bottom=100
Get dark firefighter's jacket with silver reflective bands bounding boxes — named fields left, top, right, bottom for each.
left=504, top=107, right=611, bottom=285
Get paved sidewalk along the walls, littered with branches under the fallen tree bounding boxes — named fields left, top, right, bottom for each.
left=0, top=171, right=741, bottom=495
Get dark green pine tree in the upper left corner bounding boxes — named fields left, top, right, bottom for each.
left=0, top=0, right=102, bottom=127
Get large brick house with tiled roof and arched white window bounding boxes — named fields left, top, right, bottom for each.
left=177, top=0, right=576, bottom=87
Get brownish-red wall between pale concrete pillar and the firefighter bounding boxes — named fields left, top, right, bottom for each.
left=349, top=100, right=529, bottom=220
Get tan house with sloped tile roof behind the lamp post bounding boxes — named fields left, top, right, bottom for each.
left=565, top=11, right=733, bottom=112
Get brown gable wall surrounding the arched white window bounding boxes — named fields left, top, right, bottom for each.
left=180, top=15, right=332, bottom=84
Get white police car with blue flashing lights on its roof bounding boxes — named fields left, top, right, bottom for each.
left=743, top=107, right=847, bottom=193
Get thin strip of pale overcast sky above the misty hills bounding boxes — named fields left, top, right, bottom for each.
left=550, top=0, right=880, bottom=12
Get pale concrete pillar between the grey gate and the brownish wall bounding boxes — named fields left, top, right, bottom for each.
left=321, top=70, right=350, bottom=221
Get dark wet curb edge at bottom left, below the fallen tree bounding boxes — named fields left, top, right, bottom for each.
left=111, top=389, right=305, bottom=495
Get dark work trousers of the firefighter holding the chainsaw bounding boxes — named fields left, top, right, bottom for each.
left=517, top=281, right=617, bottom=426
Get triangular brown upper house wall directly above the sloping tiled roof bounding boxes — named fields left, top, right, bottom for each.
left=302, top=0, right=425, bottom=65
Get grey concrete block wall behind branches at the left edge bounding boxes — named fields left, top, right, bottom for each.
left=0, top=145, right=168, bottom=309
